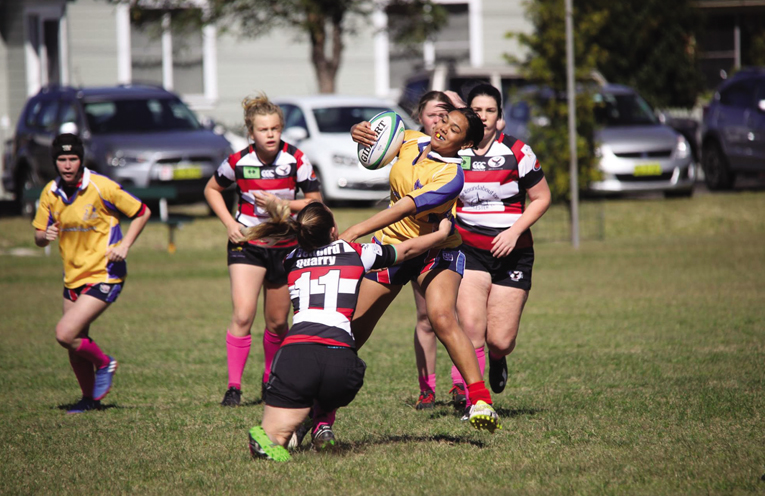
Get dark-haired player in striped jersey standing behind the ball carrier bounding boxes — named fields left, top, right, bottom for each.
left=452, top=84, right=550, bottom=410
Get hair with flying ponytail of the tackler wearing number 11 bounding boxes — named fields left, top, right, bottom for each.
left=242, top=197, right=335, bottom=251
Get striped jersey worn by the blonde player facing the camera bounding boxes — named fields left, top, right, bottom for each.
left=215, top=141, right=319, bottom=248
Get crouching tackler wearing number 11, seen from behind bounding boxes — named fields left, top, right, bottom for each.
left=242, top=201, right=452, bottom=461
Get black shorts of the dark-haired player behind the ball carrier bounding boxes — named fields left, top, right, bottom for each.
left=460, top=244, right=534, bottom=291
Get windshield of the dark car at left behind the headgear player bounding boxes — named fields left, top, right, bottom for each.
left=83, top=98, right=200, bottom=134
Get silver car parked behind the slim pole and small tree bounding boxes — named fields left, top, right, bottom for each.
left=505, top=84, right=696, bottom=196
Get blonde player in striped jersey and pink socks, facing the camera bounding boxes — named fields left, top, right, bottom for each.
left=205, top=94, right=321, bottom=406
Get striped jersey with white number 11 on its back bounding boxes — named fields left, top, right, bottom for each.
left=282, top=240, right=396, bottom=348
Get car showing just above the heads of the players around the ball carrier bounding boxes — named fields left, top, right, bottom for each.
left=398, top=64, right=526, bottom=114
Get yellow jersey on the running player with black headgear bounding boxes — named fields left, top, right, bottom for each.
left=32, top=168, right=143, bottom=289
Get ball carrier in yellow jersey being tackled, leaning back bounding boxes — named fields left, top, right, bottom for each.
left=340, top=104, right=499, bottom=431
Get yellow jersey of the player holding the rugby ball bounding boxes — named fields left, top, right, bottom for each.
left=374, top=131, right=465, bottom=249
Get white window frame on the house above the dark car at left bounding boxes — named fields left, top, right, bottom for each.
left=117, top=0, right=218, bottom=110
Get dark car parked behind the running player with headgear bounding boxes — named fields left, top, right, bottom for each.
left=3, top=85, right=231, bottom=213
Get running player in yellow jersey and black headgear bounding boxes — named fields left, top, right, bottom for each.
left=32, top=134, right=151, bottom=413
